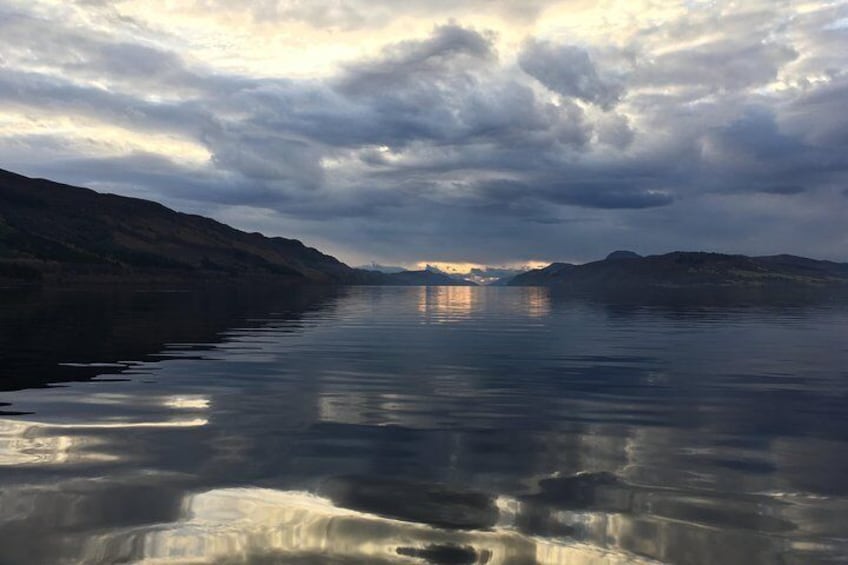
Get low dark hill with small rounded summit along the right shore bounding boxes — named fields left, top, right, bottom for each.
left=509, top=251, right=848, bottom=294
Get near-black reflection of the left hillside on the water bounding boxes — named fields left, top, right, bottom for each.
left=0, top=284, right=345, bottom=390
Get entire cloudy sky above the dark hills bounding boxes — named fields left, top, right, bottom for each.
left=0, top=0, right=848, bottom=270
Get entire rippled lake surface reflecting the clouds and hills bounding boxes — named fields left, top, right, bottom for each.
left=0, top=287, right=848, bottom=565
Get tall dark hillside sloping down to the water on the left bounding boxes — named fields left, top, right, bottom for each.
left=0, top=166, right=386, bottom=284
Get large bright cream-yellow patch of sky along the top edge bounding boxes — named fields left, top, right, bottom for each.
left=96, top=0, right=704, bottom=77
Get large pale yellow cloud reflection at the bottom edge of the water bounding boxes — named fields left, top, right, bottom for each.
left=91, top=488, right=652, bottom=565
